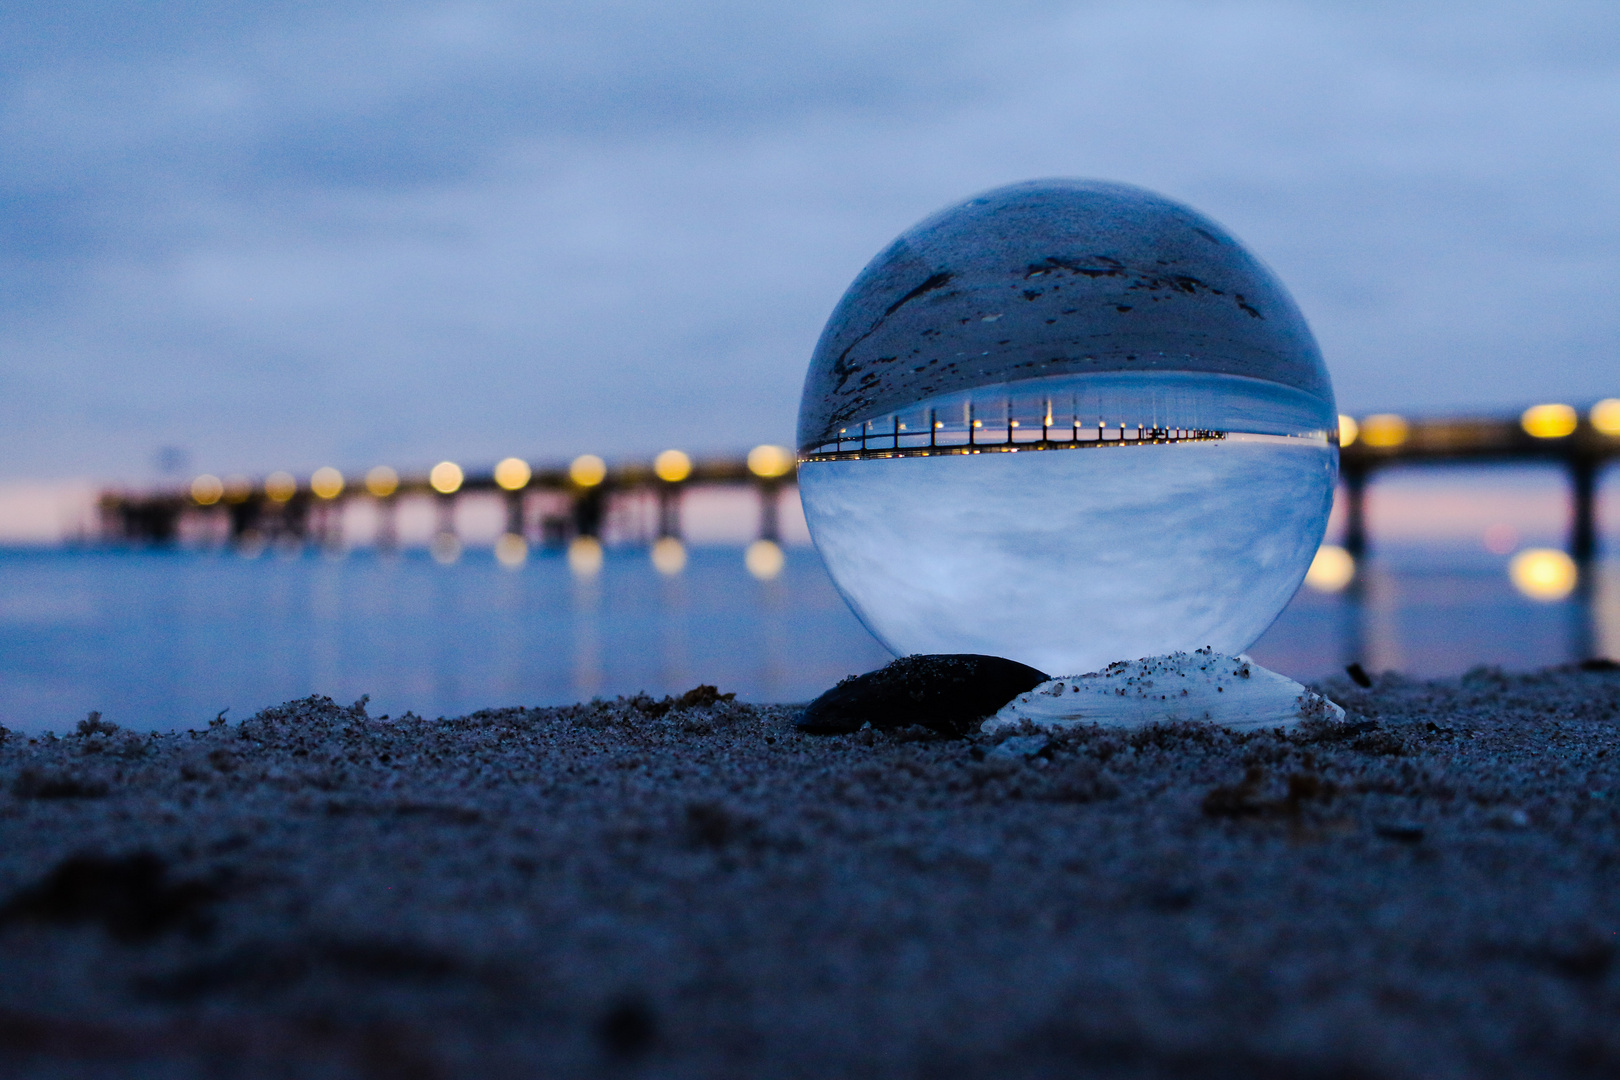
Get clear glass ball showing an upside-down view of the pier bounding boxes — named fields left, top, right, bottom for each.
left=799, top=180, right=1338, bottom=674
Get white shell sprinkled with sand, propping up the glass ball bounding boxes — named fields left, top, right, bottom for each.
left=982, top=649, right=1345, bottom=732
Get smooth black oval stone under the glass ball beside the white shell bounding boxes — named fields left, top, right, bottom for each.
left=799, top=653, right=1048, bottom=735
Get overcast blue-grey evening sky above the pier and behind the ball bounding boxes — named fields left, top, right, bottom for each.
left=0, top=0, right=1620, bottom=479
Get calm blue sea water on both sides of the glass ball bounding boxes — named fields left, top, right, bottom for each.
left=0, top=547, right=1620, bottom=730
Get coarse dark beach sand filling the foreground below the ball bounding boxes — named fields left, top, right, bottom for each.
left=0, top=667, right=1620, bottom=1080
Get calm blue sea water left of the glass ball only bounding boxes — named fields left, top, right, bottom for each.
left=0, top=547, right=888, bottom=730
